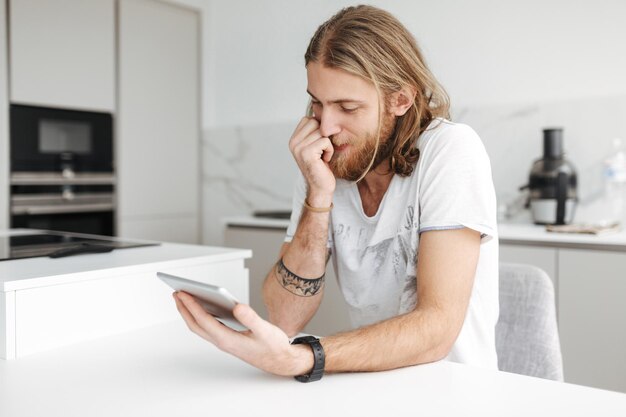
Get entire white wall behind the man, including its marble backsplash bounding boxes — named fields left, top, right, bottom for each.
left=197, top=0, right=626, bottom=244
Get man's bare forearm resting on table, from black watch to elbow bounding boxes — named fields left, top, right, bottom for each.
left=322, top=310, right=458, bottom=372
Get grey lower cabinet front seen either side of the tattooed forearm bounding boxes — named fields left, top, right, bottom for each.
left=224, top=227, right=351, bottom=336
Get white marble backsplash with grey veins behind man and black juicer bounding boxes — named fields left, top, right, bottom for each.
left=202, top=96, right=626, bottom=245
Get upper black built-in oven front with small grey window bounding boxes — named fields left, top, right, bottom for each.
left=10, top=104, right=113, bottom=172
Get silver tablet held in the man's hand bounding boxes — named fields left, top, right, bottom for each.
left=157, top=272, right=247, bottom=330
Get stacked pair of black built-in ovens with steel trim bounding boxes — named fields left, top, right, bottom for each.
left=10, top=104, right=115, bottom=236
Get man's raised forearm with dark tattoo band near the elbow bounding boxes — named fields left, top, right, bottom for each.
left=263, top=202, right=330, bottom=336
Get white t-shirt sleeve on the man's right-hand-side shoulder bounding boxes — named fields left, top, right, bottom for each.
left=417, top=124, right=497, bottom=243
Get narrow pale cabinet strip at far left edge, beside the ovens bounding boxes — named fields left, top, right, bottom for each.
left=0, top=1, right=9, bottom=230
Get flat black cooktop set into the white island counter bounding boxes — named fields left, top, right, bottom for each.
left=0, top=231, right=159, bottom=261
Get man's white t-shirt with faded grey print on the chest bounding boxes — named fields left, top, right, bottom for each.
left=285, top=119, right=499, bottom=369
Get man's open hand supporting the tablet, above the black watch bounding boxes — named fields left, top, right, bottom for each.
left=174, top=292, right=313, bottom=376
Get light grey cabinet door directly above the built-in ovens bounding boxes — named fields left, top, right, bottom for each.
left=9, top=0, right=115, bottom=112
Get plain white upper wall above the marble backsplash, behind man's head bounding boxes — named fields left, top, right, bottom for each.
left=205, top=0, right=626, bottom=127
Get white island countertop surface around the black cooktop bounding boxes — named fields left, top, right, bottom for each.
left=0, top=230, right=252, bottom=291
